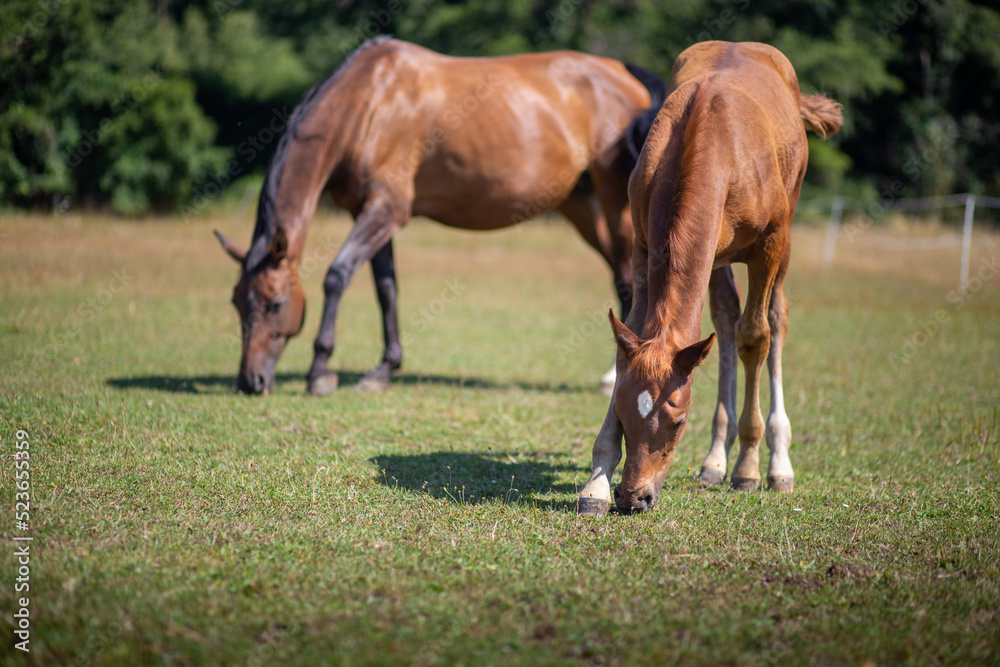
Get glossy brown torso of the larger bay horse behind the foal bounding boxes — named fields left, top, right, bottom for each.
left=314, top=40, right=650, bottom=229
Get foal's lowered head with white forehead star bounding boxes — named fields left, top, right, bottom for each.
left=608, top=312, right=715, bottom=514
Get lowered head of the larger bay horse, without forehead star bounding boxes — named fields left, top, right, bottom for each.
left=215, top=227, right=306, bottom=394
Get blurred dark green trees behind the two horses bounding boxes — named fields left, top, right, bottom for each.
left=0, top=0, right=1000, bottom=215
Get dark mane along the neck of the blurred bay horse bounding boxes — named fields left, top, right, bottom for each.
left=243, top=35, right=391, bottom=271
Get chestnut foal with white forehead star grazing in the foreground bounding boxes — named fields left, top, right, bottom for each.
left=577, top=42, right=841, bottom=515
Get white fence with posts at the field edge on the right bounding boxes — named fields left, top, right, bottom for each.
left=798, top=193, right=1000, bottom=289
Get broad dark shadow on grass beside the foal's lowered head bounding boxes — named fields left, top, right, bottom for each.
left=369, top=452, right=587, bottom=511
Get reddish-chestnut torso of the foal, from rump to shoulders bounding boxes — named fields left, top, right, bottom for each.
left=629, top=42, right=808, bottom=247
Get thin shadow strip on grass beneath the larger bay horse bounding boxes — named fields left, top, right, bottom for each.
left=105, top=371, right=596, bottom=397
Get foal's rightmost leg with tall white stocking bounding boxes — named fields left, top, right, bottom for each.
left=765, top=268, right=795, bottom=493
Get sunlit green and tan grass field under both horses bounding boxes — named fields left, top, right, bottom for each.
left=0, top=214, right=1000, bottom=665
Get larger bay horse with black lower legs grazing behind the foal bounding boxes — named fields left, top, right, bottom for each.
left=216, top=38, right=666, bottom=395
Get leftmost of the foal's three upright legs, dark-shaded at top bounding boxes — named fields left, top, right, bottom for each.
left=699, top=266, right=740, bottom=486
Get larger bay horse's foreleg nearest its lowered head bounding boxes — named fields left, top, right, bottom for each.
left=306, top=198, right=409, bottom=396
